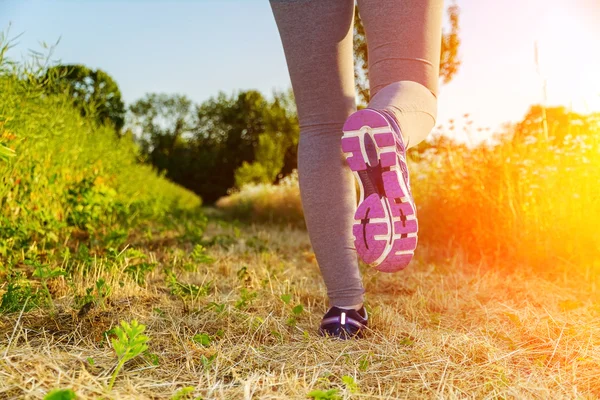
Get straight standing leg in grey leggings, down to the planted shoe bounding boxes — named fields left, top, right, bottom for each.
left=270, top=0, right=365, bottom=306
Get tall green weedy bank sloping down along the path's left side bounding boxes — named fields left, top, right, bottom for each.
left=0, top=36, right=201, bottom=313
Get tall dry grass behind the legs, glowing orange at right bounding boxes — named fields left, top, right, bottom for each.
left=217, top=114, right=600, bottom=278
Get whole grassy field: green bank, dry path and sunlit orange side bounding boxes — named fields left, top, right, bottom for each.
left=0, top=38, right=600, bottom=400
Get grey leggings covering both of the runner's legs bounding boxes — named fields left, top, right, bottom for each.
left=270, top=0, right=443, bottom=306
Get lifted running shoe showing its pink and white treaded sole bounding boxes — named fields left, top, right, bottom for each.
left=342, top=109, right=418, bottom=272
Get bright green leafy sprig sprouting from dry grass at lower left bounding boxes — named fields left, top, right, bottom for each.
left=108, top=319, right=150, bottom=390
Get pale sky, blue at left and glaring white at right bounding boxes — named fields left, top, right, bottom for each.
left=0, top=0, right=600, bottom=138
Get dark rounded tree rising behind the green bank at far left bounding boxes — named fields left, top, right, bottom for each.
left=45, top=64, right=125, bottom=132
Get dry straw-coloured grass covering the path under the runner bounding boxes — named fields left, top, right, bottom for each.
left=0, top=220, right=600, bottom=399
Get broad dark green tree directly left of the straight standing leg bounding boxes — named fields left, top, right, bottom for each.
left=195, top=90, right=299, bottom=202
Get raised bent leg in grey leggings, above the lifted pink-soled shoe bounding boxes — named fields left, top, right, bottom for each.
left=358, top=0, right=443, bottom=148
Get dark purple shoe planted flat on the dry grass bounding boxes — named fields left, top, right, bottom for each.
left=319, top=305, right=369, bottom=340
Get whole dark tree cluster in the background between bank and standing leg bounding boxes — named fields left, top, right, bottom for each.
left=129, top=91, right=298, bottom=202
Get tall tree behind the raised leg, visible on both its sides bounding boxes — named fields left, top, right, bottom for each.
left=353, top=4, right=460, bottom=104
